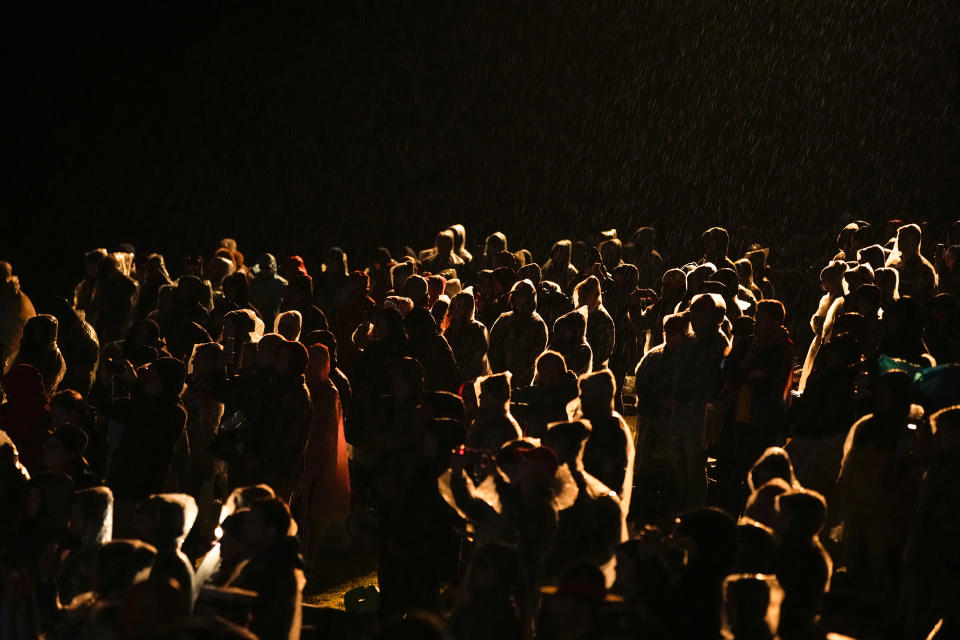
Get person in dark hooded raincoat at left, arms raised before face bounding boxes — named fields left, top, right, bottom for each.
left=107, top=358, right=187, bottom=534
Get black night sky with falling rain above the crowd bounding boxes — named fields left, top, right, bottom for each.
left=0, top=0, right=960, bottom=290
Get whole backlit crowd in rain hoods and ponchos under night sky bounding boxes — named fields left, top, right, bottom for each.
left=0, top=221, right=960, bottom=640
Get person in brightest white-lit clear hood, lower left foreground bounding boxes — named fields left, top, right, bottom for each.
left=136, top=493, right=199, bottom=609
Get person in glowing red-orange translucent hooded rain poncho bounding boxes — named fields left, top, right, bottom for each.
left=294, top=344, right=350, bottom=566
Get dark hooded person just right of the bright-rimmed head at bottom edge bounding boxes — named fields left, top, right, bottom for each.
left=774, top=489, right=833, bottom=640
